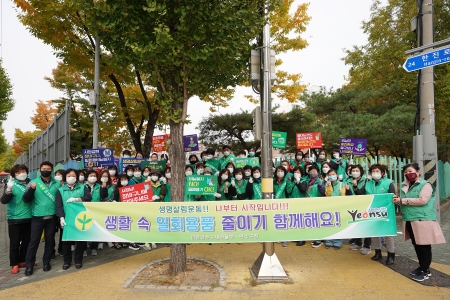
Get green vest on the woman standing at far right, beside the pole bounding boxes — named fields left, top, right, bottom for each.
left=400, top=178, right=436, bottom=221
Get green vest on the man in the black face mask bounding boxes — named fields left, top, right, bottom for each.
left=31, top=177, right=61, bottom=217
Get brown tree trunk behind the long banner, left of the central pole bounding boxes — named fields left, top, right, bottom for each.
left=169, top=99, right=186, bottom=275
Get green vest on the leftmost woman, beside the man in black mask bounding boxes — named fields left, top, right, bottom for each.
left=6, top=179, right=31, bottom=220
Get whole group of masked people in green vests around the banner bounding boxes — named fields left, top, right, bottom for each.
left=1, top=146, right=445, bottom=281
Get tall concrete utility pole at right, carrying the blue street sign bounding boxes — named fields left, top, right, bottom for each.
left=417, top=0, right=440, bottom=221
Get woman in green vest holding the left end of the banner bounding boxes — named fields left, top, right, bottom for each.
left=55, top=169, right=91, bottom=270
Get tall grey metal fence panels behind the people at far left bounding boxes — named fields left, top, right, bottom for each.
left=16, top=102, right=70, bottom=172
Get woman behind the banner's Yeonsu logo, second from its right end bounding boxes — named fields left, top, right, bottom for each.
left=347, top=165, right=372, bottom=255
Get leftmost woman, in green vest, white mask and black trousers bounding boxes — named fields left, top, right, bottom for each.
left=0, top=165, right=31, bottom=274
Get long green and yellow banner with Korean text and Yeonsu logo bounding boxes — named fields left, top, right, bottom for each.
left=63, top=194, right=397, bottom=243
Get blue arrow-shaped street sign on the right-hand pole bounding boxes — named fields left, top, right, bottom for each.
left=403, top=46, right=450, bottom=72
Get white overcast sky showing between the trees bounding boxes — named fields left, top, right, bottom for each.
left=0, top=0, right=372, bottom=143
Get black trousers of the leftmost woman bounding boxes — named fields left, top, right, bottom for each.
left=8, top=221, right=31, bottom=267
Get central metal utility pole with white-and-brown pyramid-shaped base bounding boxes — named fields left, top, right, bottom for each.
left=251, top=1, right=288, bottom=281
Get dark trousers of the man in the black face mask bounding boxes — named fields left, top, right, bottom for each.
left=25, top=217, right=55, bottom=268
